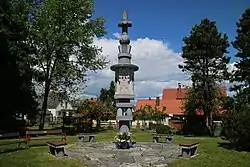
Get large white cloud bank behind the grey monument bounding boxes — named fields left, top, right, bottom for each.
left=85, top=33, right=237, bottom=98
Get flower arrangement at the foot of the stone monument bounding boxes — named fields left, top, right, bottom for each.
left=114, top=132, right=132, bottom=149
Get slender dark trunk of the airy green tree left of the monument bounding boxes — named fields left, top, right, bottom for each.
left=39, top=82, right=49, bottom=130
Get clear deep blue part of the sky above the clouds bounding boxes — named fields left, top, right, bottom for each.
left=95, top=0, right=250, bottom=61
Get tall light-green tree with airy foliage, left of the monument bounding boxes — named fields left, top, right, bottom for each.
left=29, top=0, right=107, bottom=129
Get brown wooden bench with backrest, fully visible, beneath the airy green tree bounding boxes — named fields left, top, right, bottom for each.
left=25, top=129, right=66, bottom=146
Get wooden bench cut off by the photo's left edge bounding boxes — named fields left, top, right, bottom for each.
left=0, top=132, right=26, bottom=148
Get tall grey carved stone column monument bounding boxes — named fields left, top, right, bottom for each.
left=111, top=11, right=139, bottom=131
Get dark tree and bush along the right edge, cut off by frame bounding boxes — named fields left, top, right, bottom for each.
left=222, top=8, right=250, bottom=151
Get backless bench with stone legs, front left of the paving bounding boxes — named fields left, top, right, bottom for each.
left=47, top=141, right=67, bottom=157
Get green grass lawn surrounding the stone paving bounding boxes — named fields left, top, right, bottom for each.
left=0, top=131, right=250, bottom=167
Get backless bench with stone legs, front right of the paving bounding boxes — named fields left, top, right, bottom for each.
left=179, top=142, right=199, bottom=158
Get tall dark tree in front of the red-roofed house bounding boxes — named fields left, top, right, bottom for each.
left=179, top=18, right=230, bottom=134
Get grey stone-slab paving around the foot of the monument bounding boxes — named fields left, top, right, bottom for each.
left=66, top=142, right=180, bottom=167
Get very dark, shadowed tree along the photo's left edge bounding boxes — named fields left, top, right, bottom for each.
left=0, top=0, right=37, bottom=129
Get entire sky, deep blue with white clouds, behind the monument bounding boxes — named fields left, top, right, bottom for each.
left=85, top=0, right=250, bottom=99
